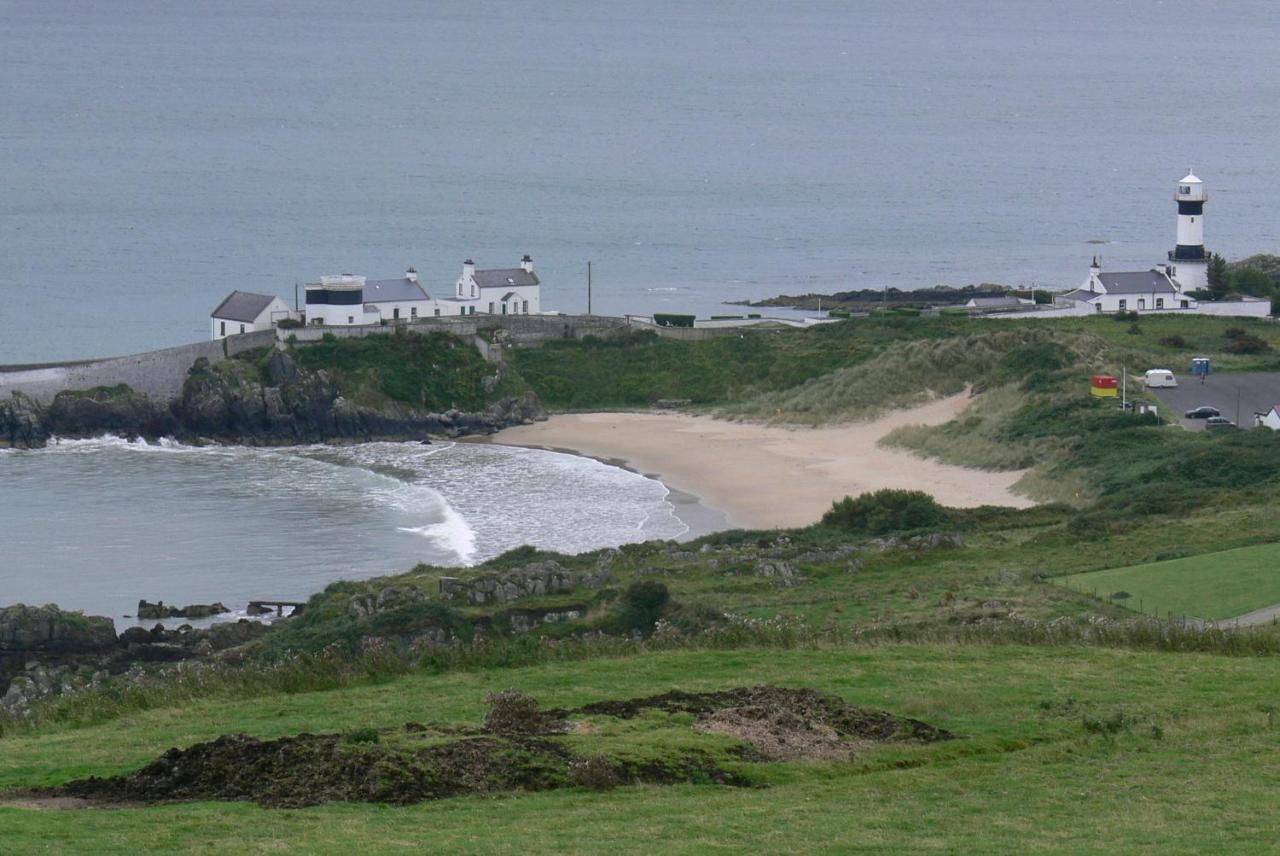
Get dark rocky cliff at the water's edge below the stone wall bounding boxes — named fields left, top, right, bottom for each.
left=0, top=353, right=547, bottom=448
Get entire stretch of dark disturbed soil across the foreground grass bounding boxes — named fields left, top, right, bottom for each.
left=40, top=686, right=951, bottom=807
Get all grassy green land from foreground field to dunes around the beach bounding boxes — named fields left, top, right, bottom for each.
left=0, top=317, right=1280, bottom=852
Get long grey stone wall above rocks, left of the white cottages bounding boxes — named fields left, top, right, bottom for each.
left=0, top=330, right=275, bottom=404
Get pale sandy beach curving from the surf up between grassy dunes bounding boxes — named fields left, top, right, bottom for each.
left=492, top=394, right=1033, bottom=528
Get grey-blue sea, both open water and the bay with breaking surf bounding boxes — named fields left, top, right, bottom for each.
left=0, top=0, right=1280, bottom=615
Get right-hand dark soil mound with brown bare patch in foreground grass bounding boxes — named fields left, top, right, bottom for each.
left=573, top=685, right=955, bottom=760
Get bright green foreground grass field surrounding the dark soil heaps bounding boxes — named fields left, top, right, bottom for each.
left=0, top=646, right=1280, bottom=853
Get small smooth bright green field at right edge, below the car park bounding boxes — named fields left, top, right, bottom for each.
left=1060, top=544, right=1280, bottom=621
